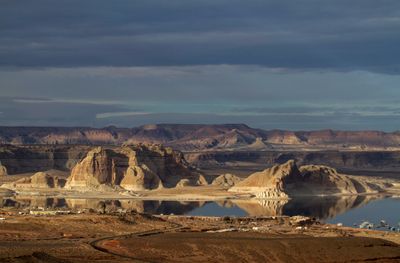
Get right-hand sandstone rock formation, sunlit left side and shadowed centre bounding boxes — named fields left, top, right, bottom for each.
left=229, top=160, right=390, bottom=199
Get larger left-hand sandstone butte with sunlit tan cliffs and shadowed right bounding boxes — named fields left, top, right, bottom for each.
left=66, top=145, right=206, bottom=191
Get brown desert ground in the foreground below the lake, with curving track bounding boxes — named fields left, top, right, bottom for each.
left=0, top=212, right=400, bottom=262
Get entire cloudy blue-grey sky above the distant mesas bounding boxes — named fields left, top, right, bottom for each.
left=0, top=0, right=400, bottom=131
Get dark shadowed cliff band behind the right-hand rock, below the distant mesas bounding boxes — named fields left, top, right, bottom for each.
left=185, top=149, right=400, bottom=171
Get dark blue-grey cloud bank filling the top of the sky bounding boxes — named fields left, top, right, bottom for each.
left=0, top=0, right=400, bottom=74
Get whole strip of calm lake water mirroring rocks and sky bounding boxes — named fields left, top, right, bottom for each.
left=0, top=196, right=400, bottom=230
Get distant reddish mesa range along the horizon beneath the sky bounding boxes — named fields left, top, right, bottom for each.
left=0, top=124, right=400, bottom=151
